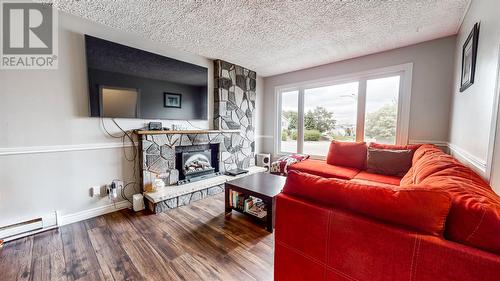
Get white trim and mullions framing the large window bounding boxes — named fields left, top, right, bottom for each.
left=274, top=62, right=413, bottom=159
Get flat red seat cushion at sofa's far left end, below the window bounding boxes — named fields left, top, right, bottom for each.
left=288, top=159, right=359, bottom=179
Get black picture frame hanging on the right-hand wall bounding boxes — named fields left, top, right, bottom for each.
left=460, top=23, right=479, bottom=92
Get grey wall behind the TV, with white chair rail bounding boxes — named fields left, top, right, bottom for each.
left=0, top=13, right=213, bottom=225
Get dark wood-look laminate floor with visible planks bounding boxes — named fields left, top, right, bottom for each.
left=0, top=194, right=274, bottom=280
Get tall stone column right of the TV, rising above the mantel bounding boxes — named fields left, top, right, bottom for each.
left=214, top=60, right=257, bottom=169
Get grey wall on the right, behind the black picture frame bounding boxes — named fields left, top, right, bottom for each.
left=450, top=0, right=500, bottom=194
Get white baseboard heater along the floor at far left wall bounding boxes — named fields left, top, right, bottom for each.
left=0, top=212, right=57, bottom=242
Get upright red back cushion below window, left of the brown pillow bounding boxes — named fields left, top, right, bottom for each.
left=326, top=141, right=367, bottom=170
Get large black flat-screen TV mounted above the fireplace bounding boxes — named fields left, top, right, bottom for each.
left=85, top=35, right=208, bottom=120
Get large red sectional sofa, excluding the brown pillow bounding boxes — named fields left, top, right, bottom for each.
left=274, top=142, right=500, bottom=281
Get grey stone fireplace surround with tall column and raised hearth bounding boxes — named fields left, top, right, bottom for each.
left=139, top=60, right=256, bottom=212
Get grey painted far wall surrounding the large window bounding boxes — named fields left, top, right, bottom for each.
left=257, top=36, right=456, bottom=153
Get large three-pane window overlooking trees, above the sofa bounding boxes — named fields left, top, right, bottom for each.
left=275, top=63, right=412, bottom=157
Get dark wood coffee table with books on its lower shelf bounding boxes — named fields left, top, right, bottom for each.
left=225, top=173, right=286, bottom=232
